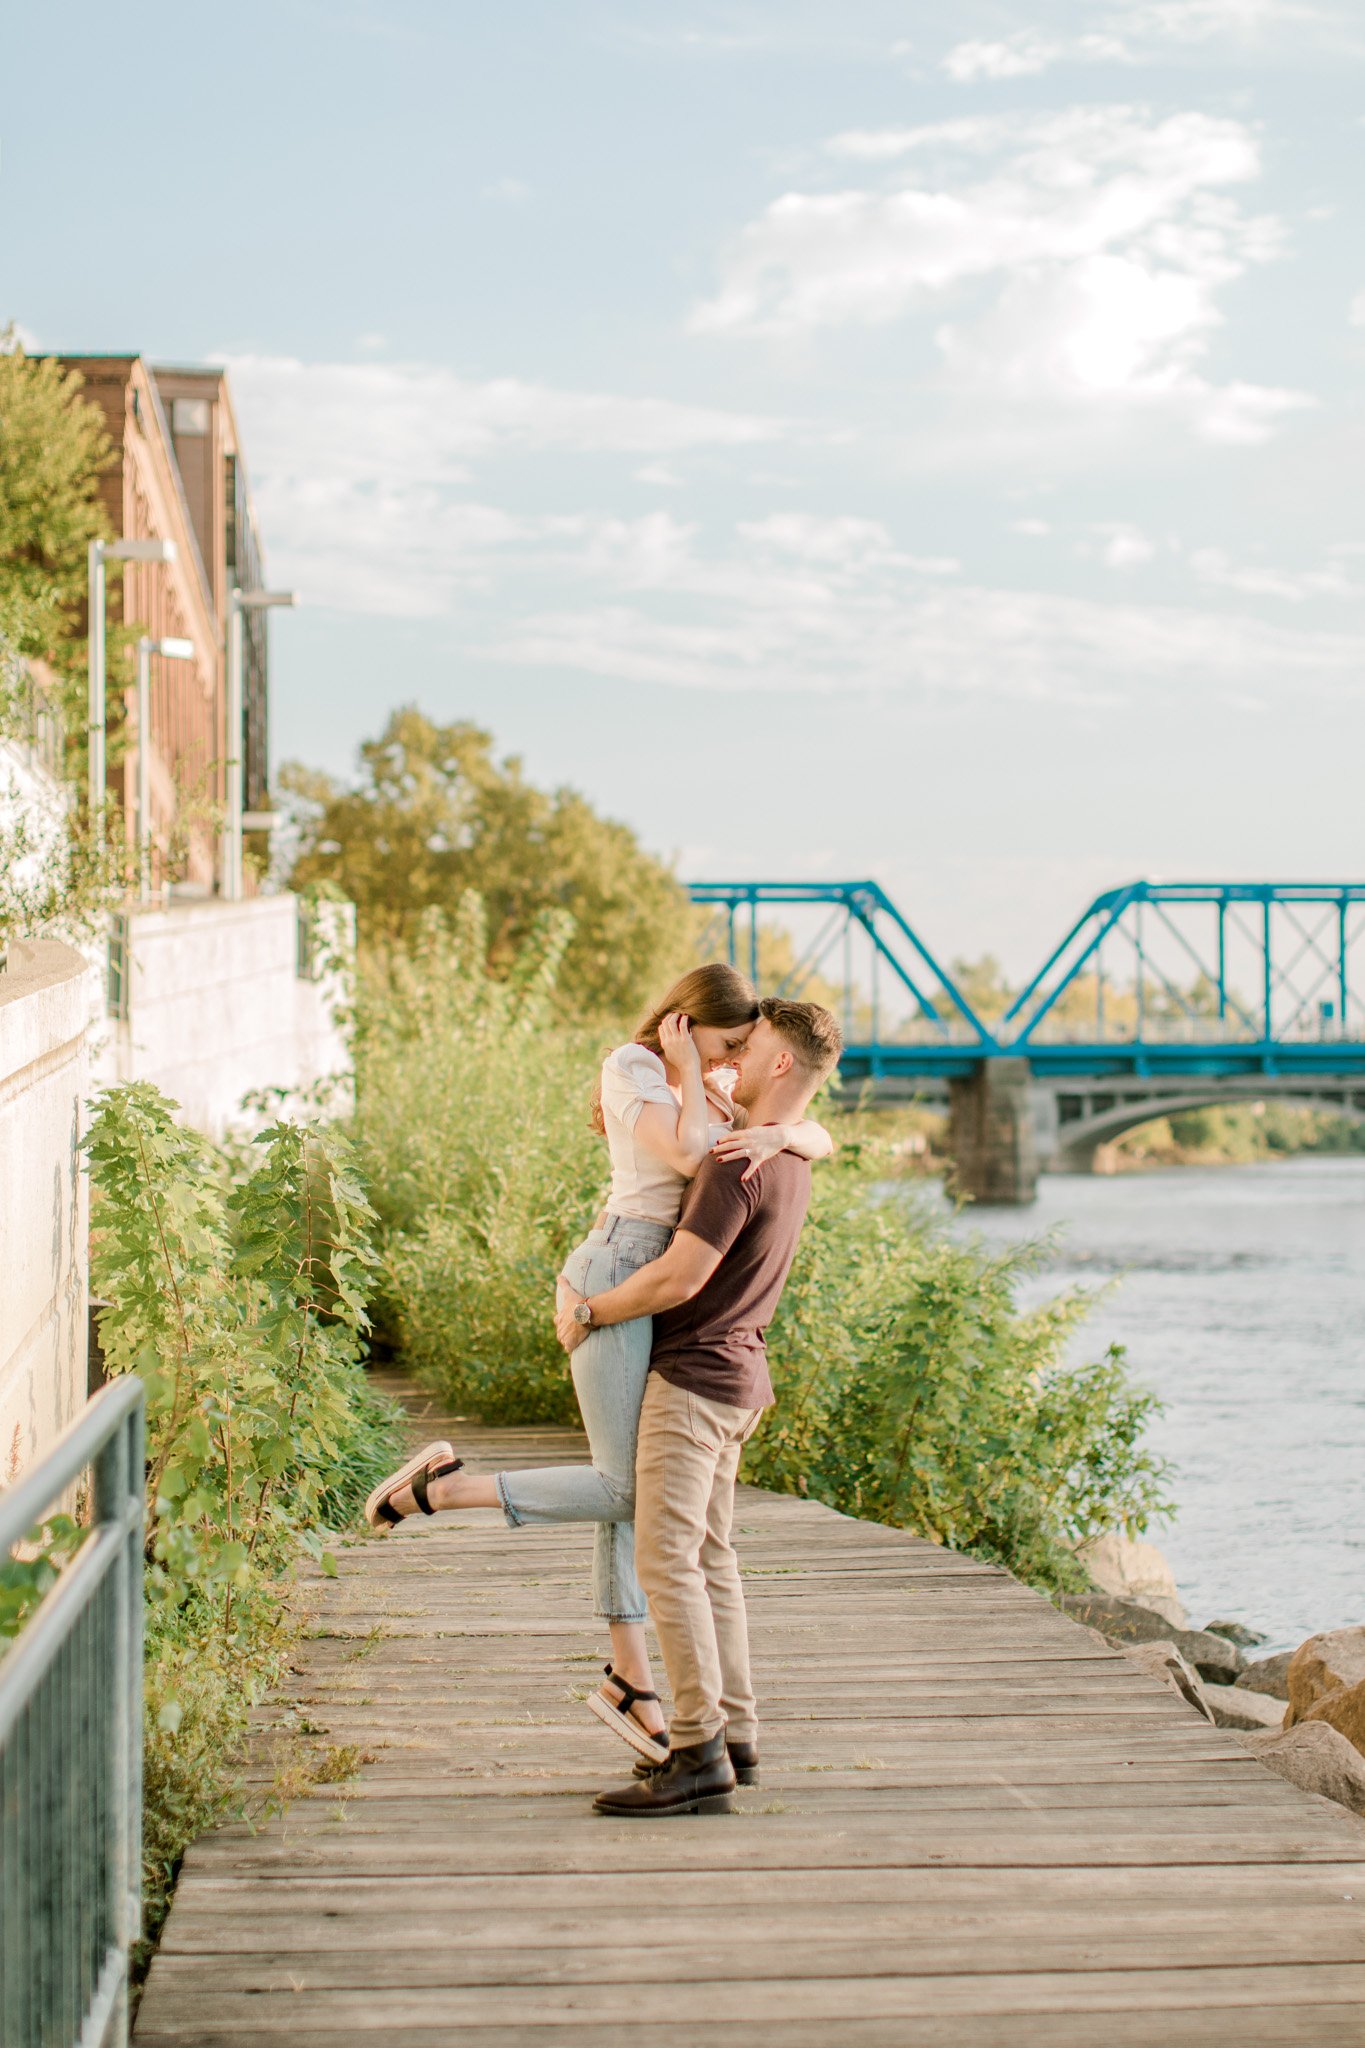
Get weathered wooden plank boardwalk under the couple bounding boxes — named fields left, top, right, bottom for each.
left=137, top=1401, right=1365, bottom=2048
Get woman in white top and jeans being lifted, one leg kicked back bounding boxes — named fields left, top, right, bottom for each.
left=364, top=963, right=833, bottom=1761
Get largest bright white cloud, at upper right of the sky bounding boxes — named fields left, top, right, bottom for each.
left=692, top=106, right=1312, bottom=440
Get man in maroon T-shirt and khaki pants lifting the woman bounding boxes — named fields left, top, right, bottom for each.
left=557, top=997, right=841, bottom=1815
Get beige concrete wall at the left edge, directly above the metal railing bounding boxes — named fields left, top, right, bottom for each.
left=0, top=940, right=92, bottom=1485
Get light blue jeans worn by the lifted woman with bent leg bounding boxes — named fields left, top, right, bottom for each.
left=497, top=1214, right=673, bottom=1622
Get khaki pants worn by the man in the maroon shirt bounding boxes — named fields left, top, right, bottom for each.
left=634, top=1372, right=763, bottom=1749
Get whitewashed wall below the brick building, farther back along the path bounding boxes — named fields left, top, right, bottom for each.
left=96, top=895, right=354, bottom=1137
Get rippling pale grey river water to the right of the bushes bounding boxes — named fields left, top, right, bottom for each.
left=958, top=1157, right=1365, bottom=1649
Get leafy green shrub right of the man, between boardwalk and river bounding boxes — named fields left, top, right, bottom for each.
left=745, top=1137, right=1164, bottom=1587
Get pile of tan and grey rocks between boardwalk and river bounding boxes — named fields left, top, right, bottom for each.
left=1058, top=1536, right=1365, bottom=1815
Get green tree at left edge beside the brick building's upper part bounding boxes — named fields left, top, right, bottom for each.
left=0, top=332, right=113, bottom=690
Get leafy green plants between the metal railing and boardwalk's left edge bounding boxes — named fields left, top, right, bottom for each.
left=86, top=1081, right=397, bottom=1927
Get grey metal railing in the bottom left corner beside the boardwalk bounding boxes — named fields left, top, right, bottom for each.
left=0, top=1376, right=143, bottom=2048
